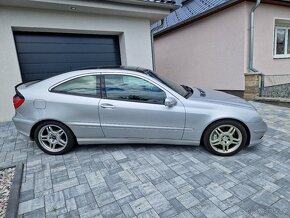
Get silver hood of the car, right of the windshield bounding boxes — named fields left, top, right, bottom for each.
left=188, top=88, right=254, bottom=109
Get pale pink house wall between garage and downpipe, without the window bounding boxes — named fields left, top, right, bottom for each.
left=154, top=3, right=248, bottom=90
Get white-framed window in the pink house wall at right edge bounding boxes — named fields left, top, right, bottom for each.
left=274, top=26, right=290, bottom=58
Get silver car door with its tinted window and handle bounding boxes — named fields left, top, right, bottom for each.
left=99, top=74, right=185, bottom=140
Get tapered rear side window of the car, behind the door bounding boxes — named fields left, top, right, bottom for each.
left=52, top=76, right=100, bottom=97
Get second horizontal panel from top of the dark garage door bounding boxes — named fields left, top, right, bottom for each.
left=18, top=43, right=118, bottom=54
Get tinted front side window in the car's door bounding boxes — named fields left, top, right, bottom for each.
left=105, top=75, right=166, bottom=104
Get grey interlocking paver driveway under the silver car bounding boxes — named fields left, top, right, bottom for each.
left=0, top=103, right=290, bottom=218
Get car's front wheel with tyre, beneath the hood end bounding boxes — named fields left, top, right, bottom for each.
left=202, top=120, right=248, bottom=156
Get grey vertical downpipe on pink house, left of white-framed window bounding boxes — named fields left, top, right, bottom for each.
left=249, top=0, right=261, bottom=73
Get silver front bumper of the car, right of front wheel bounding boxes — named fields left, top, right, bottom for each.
left=247, top=120, right=268, bottom=146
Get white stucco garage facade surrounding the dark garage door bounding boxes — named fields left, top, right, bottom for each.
left=0, top=1, right=174, bottom=122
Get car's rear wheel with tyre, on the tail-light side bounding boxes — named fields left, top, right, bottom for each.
left=34, top=121, right=76, bottom=155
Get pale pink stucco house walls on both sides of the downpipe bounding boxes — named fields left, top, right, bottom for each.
left=154, top=1, right=290, bottom=91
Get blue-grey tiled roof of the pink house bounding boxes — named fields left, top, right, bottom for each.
left=152, top=0, right=231, bottom=35
